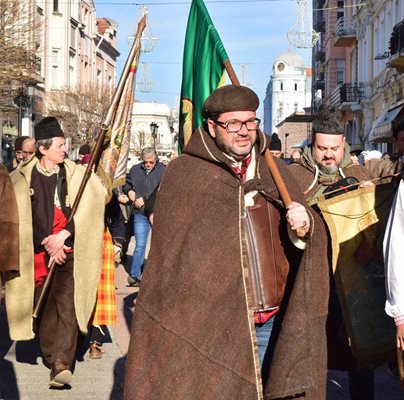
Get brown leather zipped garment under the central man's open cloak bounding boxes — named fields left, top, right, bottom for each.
left=245, top=194, right=289, bottom=311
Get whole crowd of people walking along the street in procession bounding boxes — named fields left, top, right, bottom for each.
left=0, top=85, right=404, bottom=400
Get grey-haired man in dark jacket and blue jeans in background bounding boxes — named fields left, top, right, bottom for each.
left=125, top=147, right=165, bottom=286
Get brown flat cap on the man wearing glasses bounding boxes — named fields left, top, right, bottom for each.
left=202, top=85, right=260, bottom=119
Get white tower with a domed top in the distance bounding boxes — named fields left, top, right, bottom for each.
left=264, top=50, right=311, bottom=134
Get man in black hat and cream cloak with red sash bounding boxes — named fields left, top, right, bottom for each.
left=6, top=117, right=105, bottom=388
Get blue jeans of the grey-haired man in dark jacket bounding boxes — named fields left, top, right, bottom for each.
left=130, top=211, right=151, bottom=280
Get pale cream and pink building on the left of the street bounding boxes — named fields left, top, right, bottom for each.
left=20, top=0, right=119, bottom=136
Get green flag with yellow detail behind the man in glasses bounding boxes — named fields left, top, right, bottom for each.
left=179, top=0, right=229, bottom=151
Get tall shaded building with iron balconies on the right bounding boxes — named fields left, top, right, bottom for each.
left=313, top=0, right=404, bottom=151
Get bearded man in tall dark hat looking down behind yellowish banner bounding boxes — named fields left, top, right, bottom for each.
left=289, top=106, right=374, bottom=400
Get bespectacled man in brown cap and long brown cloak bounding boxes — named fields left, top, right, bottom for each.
left=125, top=85, right=328, bottom=400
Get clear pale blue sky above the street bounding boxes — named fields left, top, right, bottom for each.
left=94, top=0, right=311, bottom=118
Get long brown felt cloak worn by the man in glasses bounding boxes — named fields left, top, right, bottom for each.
left=125, top=127, right=328, bottom=400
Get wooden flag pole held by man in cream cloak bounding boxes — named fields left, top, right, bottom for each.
left=32, top=15, right=146, bottom=318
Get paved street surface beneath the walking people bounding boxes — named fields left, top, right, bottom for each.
left=0, top=256, right=404, bottom=400
